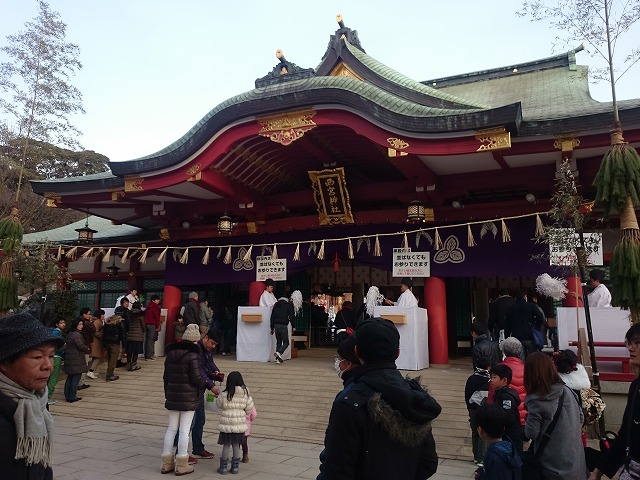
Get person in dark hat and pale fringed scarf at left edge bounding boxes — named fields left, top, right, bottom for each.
left=0, top=313, right=64, bottom=480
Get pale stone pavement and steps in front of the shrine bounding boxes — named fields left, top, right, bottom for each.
left=51, top=348, right=475, bottom=480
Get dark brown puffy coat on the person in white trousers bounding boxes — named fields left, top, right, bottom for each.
left=162, top=341, right=207, bottom=412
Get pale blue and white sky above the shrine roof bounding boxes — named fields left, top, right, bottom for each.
left=0, top=0, right=640, bottom=161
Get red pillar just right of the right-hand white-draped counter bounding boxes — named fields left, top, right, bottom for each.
left=424, top=277, right=449, bottom=365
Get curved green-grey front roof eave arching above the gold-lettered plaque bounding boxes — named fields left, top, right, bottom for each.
left=110, top=77, right=521, bottom=176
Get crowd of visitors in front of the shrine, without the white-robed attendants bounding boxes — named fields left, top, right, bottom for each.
left=0, top=270, right=640, bottom=480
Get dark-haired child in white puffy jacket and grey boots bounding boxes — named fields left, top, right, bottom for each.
left=216, top=372, right=254, bottom=475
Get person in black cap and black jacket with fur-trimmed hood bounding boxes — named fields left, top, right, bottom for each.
left=317, top=318, right=441, bottom=480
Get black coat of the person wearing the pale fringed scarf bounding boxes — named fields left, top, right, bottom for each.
left=0, top=393, right=53, bottom=480
